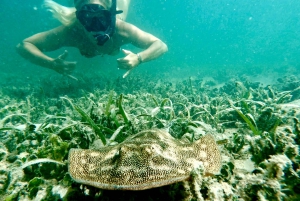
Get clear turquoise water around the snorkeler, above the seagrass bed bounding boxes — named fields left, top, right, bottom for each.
left=0, top=0, right=300, bottom=81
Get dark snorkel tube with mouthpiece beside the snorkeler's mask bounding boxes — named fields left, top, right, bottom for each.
left=93, top=0, right=123, bottom=46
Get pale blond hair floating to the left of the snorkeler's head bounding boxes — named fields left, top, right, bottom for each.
left=44, top=0, right=76, bottom=25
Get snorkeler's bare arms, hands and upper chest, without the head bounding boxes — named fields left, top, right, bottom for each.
left=17, top=0, right=168, bottom=77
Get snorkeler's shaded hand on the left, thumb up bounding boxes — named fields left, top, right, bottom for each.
left=51, top=50, right=76, bottom=76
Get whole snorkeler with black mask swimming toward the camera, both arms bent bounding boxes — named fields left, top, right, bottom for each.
left=17, top=0, right=168, bottom=78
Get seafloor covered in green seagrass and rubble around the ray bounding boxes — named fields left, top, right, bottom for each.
left=0, top=71, right=300, bottom=201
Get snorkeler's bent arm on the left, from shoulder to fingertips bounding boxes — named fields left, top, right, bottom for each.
left=16, top=26, right=76, bottom=74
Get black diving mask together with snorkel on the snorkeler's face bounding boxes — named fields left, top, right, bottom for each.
left=76, top=3, right=123, bottom=46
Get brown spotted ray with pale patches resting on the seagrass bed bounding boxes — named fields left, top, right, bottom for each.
left=69, top=130, right=221, bottom=190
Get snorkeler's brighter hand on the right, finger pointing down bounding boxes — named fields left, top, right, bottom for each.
left=117, top=49, right=140, bottom=78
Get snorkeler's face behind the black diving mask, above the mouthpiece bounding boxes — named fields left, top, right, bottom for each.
left=76, top=4, right=111, bottom=32
